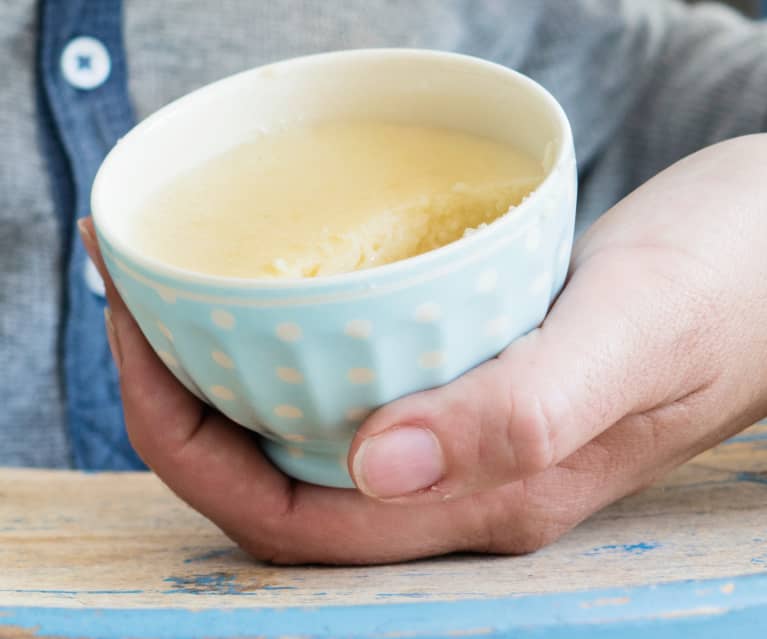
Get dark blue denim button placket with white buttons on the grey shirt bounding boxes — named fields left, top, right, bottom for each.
left=37, top=0, right=141, bottom=470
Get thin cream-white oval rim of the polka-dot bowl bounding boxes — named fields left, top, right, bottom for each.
left=91, top=48, right=573, bottom=291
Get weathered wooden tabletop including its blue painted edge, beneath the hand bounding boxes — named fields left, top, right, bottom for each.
left=0, top=425, right=767, bottom=639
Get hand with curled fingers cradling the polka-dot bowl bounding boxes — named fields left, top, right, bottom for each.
left=84, top=136, right=767, bottom=564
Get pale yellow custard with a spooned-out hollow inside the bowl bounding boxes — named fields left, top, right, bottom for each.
left=132, top=121, right=543, bottom=278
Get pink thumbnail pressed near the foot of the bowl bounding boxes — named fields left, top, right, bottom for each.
left=352, top=426, right=445, bottom=499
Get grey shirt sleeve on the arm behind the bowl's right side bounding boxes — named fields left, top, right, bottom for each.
left=462, top=0, right=767, bottom=227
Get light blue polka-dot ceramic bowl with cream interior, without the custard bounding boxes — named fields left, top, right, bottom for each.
left=93, top=50, right=577, bottom=487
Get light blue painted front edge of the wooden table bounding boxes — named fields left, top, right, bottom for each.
left=0, top=574, right=767, bottom=639
